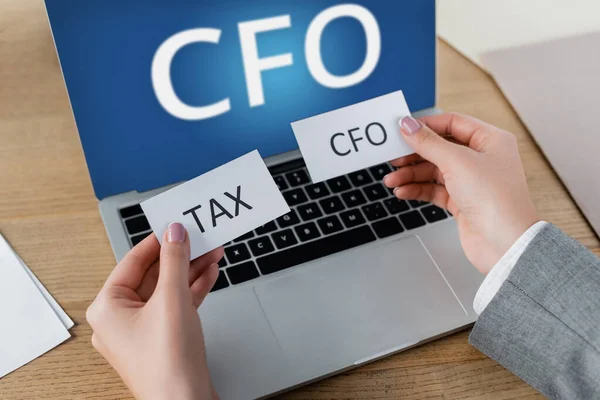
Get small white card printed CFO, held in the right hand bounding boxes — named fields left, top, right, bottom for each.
left=292, top=90, right=414, bottom=183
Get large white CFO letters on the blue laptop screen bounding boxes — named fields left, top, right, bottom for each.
left=152, top=4, right=381, bottom=121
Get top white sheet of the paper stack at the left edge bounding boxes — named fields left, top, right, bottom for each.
left=0, top=235, right=71, bottom=377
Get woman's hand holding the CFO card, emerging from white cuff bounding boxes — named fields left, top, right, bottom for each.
left=384, top=114, right=539, bottom=274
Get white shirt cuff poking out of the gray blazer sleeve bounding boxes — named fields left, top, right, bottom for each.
left=473, top=221, right=548, bottom=314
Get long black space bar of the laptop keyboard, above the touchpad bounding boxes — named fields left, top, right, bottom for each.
left=256, top=225, right=375, bottom=274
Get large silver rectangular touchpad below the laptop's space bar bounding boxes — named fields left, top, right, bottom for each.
left=255, top=236, right=467, bottom=371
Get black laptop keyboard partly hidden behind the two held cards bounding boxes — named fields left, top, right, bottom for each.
left=120, top=160, right=449, bottom=291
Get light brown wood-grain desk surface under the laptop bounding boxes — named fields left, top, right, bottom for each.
left=0, top=0, right=600, bottom=399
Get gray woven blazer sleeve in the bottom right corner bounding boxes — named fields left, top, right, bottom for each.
left=469, top=224, right=600, bottom=399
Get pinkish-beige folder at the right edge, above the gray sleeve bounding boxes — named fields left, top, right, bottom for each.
left=481, top=32, right=600, bottom=235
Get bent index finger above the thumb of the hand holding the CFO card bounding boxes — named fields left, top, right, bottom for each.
left=419, top=113, right=498, bottom=151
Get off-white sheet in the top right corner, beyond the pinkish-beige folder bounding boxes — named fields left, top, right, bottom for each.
left=436, top=0, right=600, bottom=68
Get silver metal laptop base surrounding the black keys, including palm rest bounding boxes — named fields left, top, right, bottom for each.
left=100, top=110, right=483, bottom=400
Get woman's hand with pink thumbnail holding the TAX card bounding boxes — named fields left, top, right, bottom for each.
left=87, top=223, right=223, bottom=399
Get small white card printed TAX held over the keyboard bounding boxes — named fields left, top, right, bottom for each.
left=141, top=150, right=290, bottom=259
